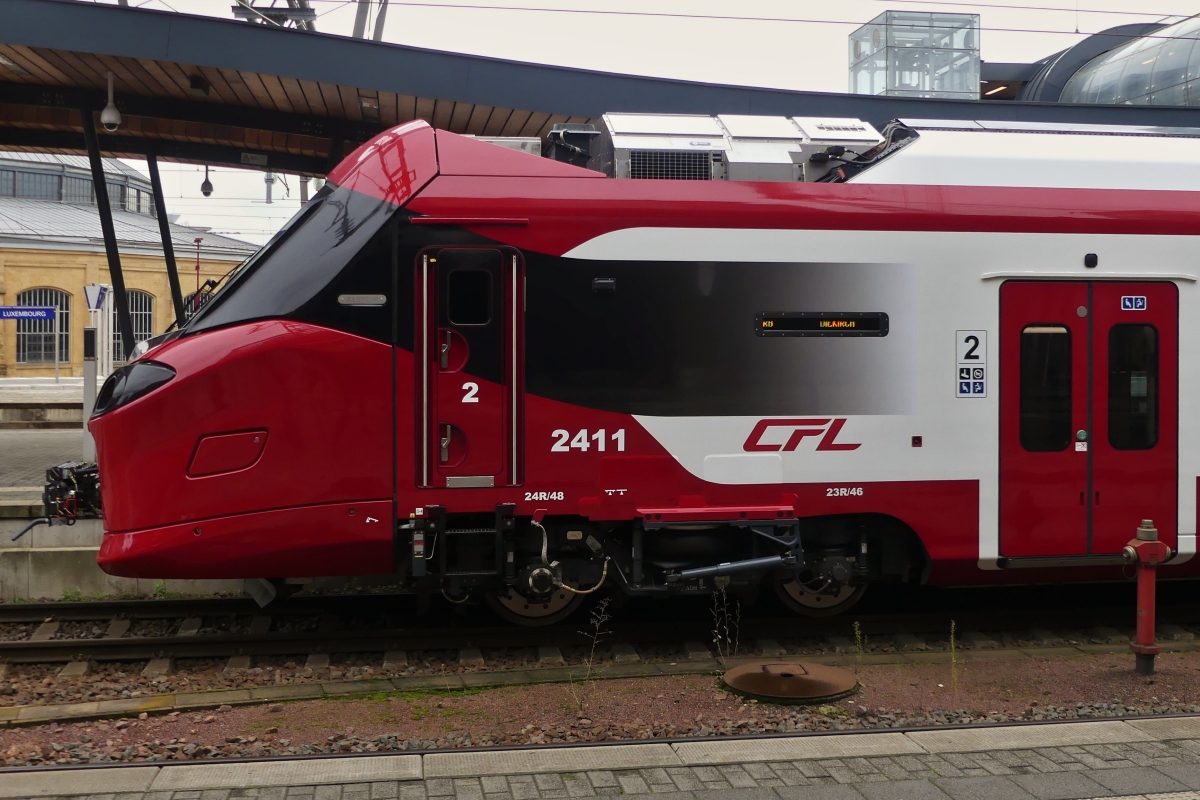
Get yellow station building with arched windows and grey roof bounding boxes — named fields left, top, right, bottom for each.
left=0, top=151, right=257, bottom=378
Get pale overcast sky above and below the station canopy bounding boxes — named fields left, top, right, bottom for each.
left=108, top=0, right=1200, bottom=243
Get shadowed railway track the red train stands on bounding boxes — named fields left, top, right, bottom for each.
left=0, top=590, right=1200, bottom=668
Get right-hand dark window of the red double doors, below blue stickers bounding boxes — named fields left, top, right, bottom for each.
left=1109, top=325, right=1158, bottom=450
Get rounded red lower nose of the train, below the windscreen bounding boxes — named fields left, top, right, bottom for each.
left=90, top=320, right=395, bottom=578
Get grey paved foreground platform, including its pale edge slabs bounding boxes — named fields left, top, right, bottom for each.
left=7, top=717, right=1200, bottom=800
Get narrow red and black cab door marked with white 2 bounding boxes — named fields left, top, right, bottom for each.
left=418, top=247, right=523, bottom=488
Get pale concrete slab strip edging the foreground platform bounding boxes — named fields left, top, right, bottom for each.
left=0, top=715, right=1200, bottom=798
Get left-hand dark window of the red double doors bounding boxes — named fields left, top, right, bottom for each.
left=1021, top=325, right=1072, bottom=452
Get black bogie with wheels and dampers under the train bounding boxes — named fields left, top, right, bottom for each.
left=395, top=505, right=928, bottom=625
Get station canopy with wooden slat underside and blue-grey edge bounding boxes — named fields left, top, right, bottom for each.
left=7, top=0, right=1200, bottom=175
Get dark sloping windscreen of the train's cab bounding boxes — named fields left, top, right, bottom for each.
left=184, top=184, right=397, bottom=335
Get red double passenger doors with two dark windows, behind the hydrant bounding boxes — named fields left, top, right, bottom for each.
left=1000, top=282, right=1178, bottom=557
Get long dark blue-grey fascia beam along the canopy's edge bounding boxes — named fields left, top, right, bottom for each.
left=9, top=0, right=1200, bottom=130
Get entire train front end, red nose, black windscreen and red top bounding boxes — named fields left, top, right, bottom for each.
left=89, top=122, right=438, bottom=578
